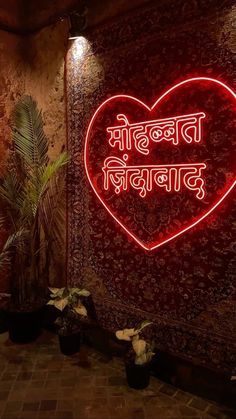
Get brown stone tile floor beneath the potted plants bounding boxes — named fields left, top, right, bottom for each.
left=0, top=332, right=236, bottom=419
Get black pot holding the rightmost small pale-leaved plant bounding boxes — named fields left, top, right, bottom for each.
left=125, top=363, right=150, bottom=390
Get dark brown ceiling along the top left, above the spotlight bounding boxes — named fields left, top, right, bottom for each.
left=0, top=0, right=149, bottom=34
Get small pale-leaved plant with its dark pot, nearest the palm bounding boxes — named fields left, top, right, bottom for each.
left=47, top=287, right=90, bottom=355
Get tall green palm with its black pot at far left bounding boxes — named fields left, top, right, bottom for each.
left=0, top=96, right=68, bottom=343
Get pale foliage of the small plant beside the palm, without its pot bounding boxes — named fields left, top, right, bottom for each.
left=47, top=287, right=90, bottom=335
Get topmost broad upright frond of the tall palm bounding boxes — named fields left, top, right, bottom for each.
left=12, top=96, right=48, bottom=170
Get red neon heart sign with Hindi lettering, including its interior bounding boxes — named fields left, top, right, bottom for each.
left=84, top=77, right=236, bottom=250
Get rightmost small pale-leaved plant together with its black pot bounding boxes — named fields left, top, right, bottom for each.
left=116, top=320, right=154, bottom=389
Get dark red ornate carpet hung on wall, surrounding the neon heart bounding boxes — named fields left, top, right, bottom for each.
left=66, top=1, right=236, bottom=371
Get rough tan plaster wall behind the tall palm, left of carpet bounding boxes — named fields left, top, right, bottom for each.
left=0, top=22, right=68, bottom=291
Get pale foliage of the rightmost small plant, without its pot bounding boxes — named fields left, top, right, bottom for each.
left=116, top=320, right=155, bottom=365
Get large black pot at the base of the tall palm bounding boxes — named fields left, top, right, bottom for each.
left=8, top=310, right=41, bottom=343
